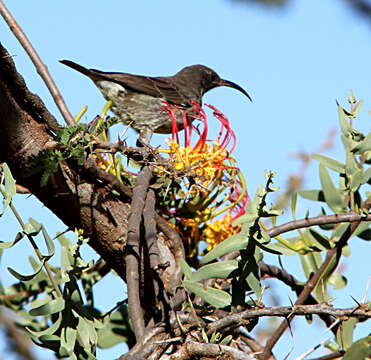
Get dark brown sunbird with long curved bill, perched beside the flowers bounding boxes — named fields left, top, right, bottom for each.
left=60, top=60, right=251, bottom=143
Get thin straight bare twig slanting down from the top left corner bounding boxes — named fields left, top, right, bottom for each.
left=0, top=0, right=75, bottom=126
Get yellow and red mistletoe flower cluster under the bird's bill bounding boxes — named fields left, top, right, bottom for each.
left=162, top=103, right=248, bottom=253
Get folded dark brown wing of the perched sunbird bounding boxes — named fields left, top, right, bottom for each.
left=91, top=69, right=190, bottom=106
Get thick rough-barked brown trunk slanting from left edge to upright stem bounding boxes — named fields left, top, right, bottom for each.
left=0, top=41, right=130, bottom=278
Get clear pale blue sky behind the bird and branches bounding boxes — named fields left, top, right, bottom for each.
left=0, top=0, right=371, bottom=359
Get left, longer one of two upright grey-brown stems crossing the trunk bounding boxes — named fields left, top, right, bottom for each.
left=125, top=167, right=152, bottom=341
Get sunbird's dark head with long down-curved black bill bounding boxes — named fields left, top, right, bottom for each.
left=178, top=65, right=252, bottom=101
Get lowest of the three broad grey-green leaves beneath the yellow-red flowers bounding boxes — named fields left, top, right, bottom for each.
left=184, top=280, right=232, bottom=309
